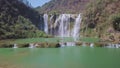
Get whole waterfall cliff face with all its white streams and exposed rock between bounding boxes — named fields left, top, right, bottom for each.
left=43, top=14, right=82, bottom=46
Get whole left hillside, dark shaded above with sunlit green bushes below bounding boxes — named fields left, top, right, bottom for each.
left=0, top=0, right=44, bottom=39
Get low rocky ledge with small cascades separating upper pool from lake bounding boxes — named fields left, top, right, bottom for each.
left=0, top=42, right=120, bottom=48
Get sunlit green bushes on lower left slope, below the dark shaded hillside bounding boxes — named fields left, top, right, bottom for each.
left=0, top=16, right=46, bottom=39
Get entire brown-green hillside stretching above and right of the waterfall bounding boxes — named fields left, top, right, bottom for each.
left=36, top=0, right=120, bottom=43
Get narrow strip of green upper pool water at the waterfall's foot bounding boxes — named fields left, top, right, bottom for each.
left=0, top=37, right=99, bottom=44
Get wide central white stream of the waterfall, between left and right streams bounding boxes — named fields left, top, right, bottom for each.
left=58, top=14, right=70, bottom=47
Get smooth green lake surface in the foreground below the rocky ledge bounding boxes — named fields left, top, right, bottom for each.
left=0, top=47, right=120, bottom=68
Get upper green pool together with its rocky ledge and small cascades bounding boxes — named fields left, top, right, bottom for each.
left=0, top=37, right=120, bottom=48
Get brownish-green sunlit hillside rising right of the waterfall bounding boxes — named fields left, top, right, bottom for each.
left=81, top=0, right=120, bottom=43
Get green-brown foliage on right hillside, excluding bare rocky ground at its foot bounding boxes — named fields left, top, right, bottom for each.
left=81, top=0, right=120, bottom=37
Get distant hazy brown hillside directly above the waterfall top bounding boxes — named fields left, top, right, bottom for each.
left=36, top=0, right=90, bottom=14
